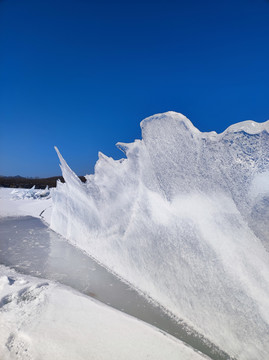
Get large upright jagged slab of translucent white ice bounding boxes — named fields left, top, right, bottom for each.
left=51, top=112, right=269, bottom=360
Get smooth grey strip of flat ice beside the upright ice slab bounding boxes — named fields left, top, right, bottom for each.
left=0, top=216, right=230, bottom=360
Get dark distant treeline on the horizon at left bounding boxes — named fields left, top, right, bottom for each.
left=0, top=176, right=86, bottom=189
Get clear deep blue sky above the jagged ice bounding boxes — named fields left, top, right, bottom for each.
left=0, top=0, right=269, bottom=177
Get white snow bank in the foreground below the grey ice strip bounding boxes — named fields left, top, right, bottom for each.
left=0, top=266, right=207, bottom=360
